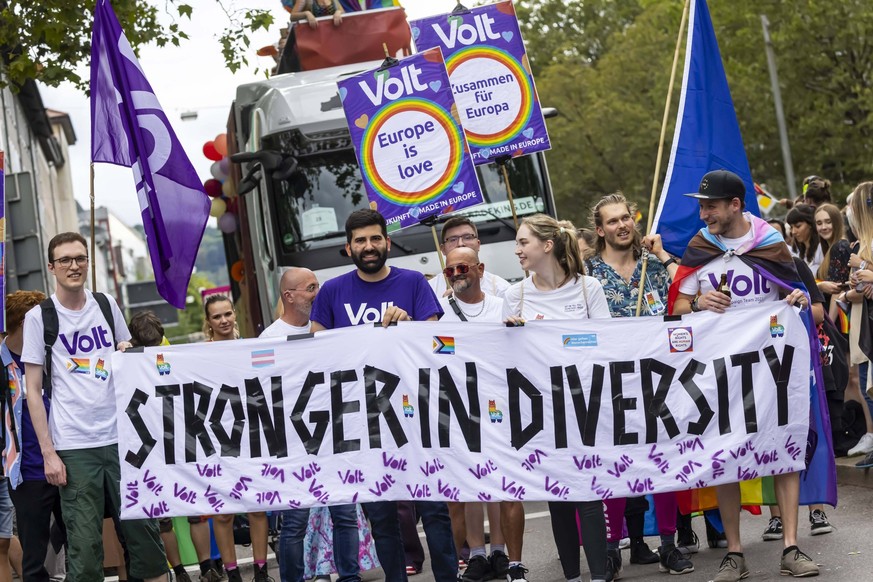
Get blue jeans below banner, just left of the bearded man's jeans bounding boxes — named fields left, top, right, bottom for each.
left=279, top=504, right=361, bottom=582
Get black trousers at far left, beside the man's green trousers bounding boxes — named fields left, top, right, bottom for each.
left=9, top=481, right=66, bottom=582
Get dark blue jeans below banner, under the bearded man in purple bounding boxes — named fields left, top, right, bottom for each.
left=364, top=501, right=458, bottom=582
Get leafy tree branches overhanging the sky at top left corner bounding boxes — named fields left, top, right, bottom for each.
left=0, top=0, right=273, bottom=90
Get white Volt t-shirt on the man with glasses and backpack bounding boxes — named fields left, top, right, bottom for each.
left=21, top=289, right=130, bottom=451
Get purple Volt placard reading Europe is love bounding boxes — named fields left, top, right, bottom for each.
left=338, top=49, right=482, bottom=232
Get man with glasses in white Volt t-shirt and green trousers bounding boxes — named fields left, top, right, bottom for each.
left=21, top=232, right=168, bottom=582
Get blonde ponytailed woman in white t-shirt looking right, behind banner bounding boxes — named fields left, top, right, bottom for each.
left=503, top=214, right=610, bottom=582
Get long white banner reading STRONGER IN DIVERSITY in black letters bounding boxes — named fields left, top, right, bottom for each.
left=112, top=302, right=810, bottom=518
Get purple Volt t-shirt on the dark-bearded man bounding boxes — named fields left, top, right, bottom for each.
left=309, top=267, right=443, bottom=329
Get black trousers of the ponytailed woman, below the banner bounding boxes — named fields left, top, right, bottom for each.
left=549, top=500, right=606, bottom=580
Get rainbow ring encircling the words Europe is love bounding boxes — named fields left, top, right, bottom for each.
left=361, top=97, right=466, bottom=206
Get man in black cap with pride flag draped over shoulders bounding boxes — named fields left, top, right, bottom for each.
left=670, top=170, right=818, bottom=582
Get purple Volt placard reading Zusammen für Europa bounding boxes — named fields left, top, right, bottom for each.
left=409, top=1, right=551, bottom=165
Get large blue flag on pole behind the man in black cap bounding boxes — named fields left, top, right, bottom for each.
left=652, top=0, right=760, bottom=256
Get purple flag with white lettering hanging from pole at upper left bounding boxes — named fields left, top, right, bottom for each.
left=91, top=0, right=210, bottom=309
